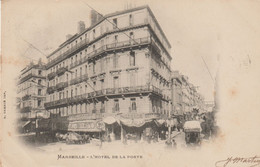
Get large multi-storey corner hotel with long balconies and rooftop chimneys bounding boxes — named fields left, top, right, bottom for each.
left=45, top=6, right=172, bottom=139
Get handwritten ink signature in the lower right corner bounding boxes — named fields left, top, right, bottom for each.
left=215, top=156, right=260, bottom=167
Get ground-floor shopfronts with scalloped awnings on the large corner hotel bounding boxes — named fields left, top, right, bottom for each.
left=38, top=113, right=177, bottom=142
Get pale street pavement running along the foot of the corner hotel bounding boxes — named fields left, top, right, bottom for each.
left=35, top=132, right=204, bottom=153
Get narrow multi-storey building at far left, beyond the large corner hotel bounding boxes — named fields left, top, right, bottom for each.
left=17, top=61, right=49, bottom=132
